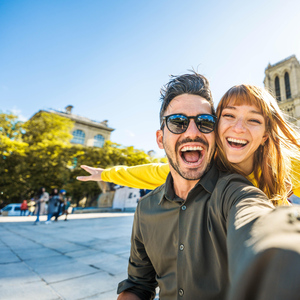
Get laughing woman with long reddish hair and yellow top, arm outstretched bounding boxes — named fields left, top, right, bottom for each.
left=77, top=85, right=300, bottom=205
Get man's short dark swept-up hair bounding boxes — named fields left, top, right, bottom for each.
left=159, top=71, right=215, bottom=125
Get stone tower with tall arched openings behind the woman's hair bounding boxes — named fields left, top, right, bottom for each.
left=264, top=55, right=300, bottom=127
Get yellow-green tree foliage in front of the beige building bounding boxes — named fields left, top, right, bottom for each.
left=0, top=111, right=162, bottom=203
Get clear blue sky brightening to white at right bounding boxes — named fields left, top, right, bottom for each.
left=0, top=0, right=300, bottom=156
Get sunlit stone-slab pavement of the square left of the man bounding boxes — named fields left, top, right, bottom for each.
left=0, top=212, right=133, bottom=300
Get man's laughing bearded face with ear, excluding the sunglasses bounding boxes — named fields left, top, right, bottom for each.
left=156, top=94, right=215, bottom=180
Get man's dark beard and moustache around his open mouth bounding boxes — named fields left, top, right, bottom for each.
left=164, top=137, right=214, bottom=180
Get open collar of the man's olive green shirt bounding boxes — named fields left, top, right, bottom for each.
left=158, top=163, right=219, bottom=204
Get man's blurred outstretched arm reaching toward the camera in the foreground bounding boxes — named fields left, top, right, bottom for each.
left=227, top=182, right=300, bottom=300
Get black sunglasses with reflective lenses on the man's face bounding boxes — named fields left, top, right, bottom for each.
left=162, top=114, right=217, bottom=134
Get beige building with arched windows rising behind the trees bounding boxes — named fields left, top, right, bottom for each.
left=48, top=105, right=114, bottom=147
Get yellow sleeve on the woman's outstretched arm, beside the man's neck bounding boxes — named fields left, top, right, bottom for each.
left=101, top=164, right=170, bottom=190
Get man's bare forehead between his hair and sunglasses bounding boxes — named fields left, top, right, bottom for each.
left=164, top=94, right=212, bottom=115
